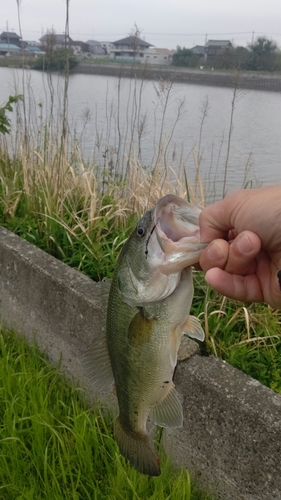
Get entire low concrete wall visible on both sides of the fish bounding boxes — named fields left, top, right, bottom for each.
left=0, top=227, right=281, bottom=500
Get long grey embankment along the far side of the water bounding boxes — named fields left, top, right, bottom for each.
left=71, top=63, right=281, bottom=92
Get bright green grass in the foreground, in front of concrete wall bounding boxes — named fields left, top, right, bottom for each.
left=0, top=332, right=214, bottom=500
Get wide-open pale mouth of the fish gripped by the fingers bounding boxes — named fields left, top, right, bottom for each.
left=154, top=194, right=207, bottom=272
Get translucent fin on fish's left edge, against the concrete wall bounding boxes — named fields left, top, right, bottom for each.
left=83, top=335, right=114, bottom=392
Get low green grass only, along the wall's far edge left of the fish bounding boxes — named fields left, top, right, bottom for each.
left=0, top=197, right=137, bottom=281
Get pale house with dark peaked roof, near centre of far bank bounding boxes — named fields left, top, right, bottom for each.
left=110, top=35, right=152, bottom=62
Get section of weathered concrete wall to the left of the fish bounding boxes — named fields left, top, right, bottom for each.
left=0, top=227, right=104, bottom=381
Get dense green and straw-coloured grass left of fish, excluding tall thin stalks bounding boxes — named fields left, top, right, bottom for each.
left=0, top=148, right=136, bottom=281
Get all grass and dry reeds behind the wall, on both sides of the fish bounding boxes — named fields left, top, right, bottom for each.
left=0, top=82, right=281, bottom=398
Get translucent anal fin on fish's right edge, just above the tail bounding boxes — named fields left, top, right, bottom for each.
left=149, top=387, right=183, bottom=427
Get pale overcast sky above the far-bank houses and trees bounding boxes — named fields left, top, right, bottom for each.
left=0, top=0, right=281, bottom=49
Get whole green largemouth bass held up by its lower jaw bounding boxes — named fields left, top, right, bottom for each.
left=85, top=195, right=206, bottom=476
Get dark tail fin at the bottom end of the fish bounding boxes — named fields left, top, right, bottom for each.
left=114, top=417, right=161, bottom=476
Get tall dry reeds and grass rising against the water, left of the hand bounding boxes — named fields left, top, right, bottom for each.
left=0, top=0, right=254, bottom=279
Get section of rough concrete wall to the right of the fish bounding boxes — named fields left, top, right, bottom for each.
left=170, top=355, right=281, bottom=500
